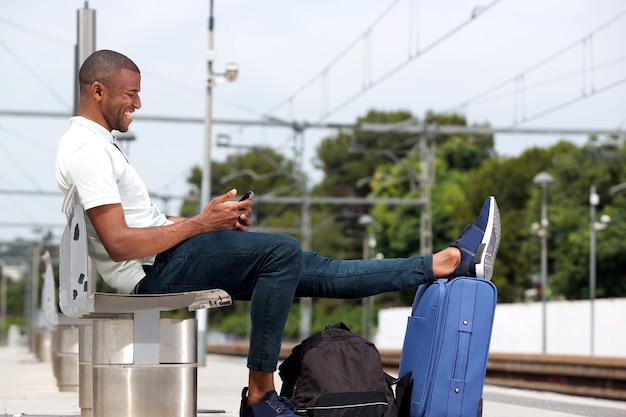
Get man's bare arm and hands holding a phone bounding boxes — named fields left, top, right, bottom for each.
left=87, top=190, right=252, bottom=262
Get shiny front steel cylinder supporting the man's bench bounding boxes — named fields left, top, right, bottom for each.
left=89, top=312, right=198, bottom=417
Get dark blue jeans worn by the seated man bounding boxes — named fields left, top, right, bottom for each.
left=137, top=230, right=434, bottom=372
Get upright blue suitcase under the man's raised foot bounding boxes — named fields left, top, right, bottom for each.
left=399, top=277, right=497, bottom=417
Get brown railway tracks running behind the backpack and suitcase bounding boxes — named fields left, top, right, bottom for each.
left=208, top=343, right=626, bottom=401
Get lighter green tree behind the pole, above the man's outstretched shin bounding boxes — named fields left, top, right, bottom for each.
left=372, top=112, right=493, bottom=257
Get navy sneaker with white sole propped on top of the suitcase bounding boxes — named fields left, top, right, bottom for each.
left=450, top=196, right=500, bottom=280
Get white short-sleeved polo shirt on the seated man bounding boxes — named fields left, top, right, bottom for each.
left=56, top=116, right=172, bottom=293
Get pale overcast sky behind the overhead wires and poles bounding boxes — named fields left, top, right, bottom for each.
left=0, top=0, right=626, bottom=242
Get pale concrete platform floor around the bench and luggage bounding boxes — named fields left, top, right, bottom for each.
left=0, top=346, right=626, bottom=417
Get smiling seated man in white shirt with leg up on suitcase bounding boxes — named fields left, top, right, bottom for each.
left=56, top=50, right=500, bottom=417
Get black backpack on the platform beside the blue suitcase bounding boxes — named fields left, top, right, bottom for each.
left=279, top=323, right=409, bottom=417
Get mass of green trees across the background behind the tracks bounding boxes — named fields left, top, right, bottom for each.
left=180, top=110, right=626, bottom=338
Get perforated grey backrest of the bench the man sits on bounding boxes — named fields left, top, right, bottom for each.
left=59, top=185, right=96, bottom=317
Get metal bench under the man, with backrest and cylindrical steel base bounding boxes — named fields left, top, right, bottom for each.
left=59, top=186, right=232, bottom=417
